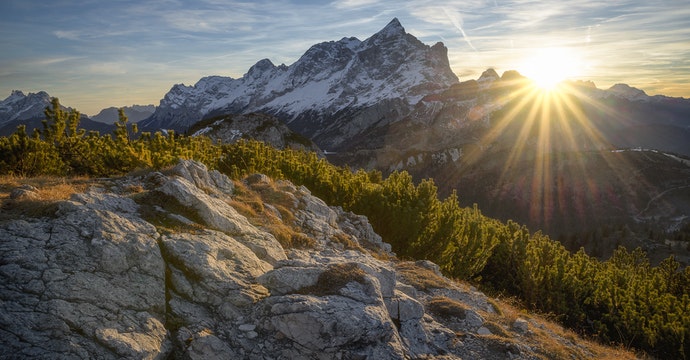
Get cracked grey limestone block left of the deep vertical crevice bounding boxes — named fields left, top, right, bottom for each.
left=0, top=192, right=172, bottom=359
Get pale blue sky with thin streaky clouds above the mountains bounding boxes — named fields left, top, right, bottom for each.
left=0, top=0, right=690, bottom=115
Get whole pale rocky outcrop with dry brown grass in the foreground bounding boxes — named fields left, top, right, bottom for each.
left=0, top=161, right=630, bottom=359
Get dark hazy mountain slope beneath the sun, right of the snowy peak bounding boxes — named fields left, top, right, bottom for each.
left=342, top=71, right=690, bottom=264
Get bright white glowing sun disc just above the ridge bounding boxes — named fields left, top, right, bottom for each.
left=518, top=48, right=582, bottom=90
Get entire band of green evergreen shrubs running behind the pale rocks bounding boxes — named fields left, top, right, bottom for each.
left=0, top=99, right=690, bottom=358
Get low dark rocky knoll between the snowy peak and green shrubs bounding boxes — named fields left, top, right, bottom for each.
left=187, top=113, right=325, bottom=156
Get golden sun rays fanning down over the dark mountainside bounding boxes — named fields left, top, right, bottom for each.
left=470, top=77, right=626, bottom=226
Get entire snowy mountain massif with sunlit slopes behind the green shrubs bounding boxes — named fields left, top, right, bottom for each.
left=140, top=19, right=690, bottom=263
